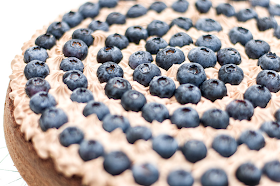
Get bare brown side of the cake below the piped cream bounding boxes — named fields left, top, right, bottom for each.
left=4, top=86, right=82, bottom=186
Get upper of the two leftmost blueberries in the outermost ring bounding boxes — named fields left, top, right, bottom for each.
left=23, top=46, right=49, bottom=63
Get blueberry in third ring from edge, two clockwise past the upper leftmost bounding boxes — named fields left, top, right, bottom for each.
left=125, top=26, right=148, bottom=45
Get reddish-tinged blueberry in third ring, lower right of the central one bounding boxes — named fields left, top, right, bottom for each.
left=226, top=100, right=254, bottom=121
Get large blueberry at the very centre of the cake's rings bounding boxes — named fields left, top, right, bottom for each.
left=177, top=63, right=206, bottom=87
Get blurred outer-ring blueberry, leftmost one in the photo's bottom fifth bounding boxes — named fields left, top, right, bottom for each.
left=79, top=140, right=104, bottom=161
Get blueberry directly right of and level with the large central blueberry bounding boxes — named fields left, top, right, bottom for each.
left=218, top=64, right=244, bottom=85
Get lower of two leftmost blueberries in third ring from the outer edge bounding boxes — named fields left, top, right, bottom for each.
left=96, top=62, right=123, bottom=83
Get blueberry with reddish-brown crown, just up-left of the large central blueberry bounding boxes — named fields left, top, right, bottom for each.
left=156, top=47, right=185, bottom=70
